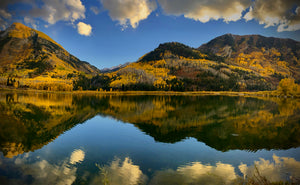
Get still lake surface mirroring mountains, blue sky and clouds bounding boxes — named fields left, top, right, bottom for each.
left=0, top=93, right=300, bottom=185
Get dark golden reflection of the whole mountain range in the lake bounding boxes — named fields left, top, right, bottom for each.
left=0, top=93, right=300, bottom=158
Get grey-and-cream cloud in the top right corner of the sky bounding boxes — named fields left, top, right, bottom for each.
left=244, top=0, right=300, bottom=32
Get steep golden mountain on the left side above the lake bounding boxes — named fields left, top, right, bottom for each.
left=0, top=23, right=100, bottom=89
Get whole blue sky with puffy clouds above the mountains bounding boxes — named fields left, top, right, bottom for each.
left=0, top=0, right=300, bottom=69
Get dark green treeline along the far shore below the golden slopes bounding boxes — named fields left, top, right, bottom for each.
left=73, top=72, right=270, bottom=92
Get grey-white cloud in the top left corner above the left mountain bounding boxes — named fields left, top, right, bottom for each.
left=0, top=0, right=86, bottom=31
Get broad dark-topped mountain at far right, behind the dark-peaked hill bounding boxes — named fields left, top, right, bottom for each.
left=198, top=34, right=300, bottom=81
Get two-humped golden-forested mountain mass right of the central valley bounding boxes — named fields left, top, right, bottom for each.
left=104, top=34, right=300, bottom=91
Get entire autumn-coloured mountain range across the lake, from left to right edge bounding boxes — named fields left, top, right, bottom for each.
left=0, top=23, right=300, bottom=94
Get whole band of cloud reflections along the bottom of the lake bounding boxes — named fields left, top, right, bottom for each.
left=0, top=152, right=300, bottom=185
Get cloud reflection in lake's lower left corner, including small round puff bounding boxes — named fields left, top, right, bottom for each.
left=0, top=149, right=84, bottom=185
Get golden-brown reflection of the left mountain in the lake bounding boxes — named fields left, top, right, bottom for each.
left=0, top=93, right=96, bottom=158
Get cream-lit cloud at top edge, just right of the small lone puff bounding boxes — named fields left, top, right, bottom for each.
left=101, top=0, right=156, bottom=28
